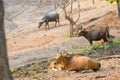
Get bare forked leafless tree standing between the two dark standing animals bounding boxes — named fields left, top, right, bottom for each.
left=55, top=0, right=80, bottom=37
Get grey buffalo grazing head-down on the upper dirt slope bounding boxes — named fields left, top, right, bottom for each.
left=38, top=11, right=59, bottom=29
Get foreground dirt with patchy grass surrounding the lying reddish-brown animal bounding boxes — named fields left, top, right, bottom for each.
left=13, top=45, right=120, bottom=80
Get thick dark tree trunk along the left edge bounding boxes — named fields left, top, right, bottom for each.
left=0, top=0, right=13, bottom=80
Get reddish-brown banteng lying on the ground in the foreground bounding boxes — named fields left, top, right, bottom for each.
left=49, top=54, right=101, bottom=71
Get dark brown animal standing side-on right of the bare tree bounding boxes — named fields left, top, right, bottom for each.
left=78, top=29, right=108, bottom=45
